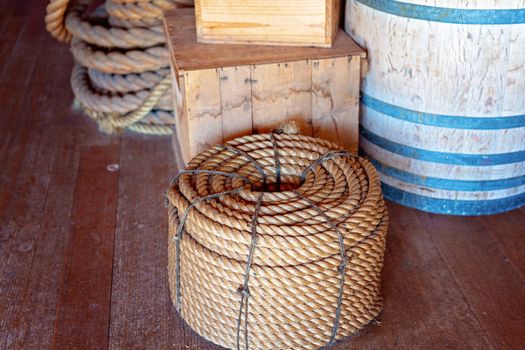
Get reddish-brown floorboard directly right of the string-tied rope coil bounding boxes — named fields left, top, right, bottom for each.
left=341, top=203, right=492, bottom=349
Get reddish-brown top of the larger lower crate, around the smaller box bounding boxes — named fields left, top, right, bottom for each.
left=164, top=9, right=366, bottom=71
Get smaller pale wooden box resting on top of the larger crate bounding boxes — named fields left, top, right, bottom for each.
left=195, top=0, right=340, bottom=47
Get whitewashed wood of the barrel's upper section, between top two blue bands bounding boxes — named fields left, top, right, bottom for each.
left=346, top=0, right=525, bottom=117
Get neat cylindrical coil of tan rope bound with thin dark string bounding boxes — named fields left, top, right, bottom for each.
left=166, top=133, right=388, bottom=349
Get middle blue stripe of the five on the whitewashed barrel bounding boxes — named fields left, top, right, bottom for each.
left=360, top=126, right=525, bottom=166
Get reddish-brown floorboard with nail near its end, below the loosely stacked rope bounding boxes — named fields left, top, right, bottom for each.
left=53, top=143, right=119, bottom=349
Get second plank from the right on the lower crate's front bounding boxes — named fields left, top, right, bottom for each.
left=252, top=61, right=312, bottom=135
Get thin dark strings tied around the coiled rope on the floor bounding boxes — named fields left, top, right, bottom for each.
left=168, top=133, right=357, bottom=350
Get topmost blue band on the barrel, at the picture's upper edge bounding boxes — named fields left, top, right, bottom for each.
left=356, top=0, right=525, bottom=25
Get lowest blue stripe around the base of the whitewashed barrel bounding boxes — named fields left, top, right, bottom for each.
left=381, top=183, right=525, bottom=216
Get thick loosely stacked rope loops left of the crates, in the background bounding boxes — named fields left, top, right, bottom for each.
left=46, top=0, right=193, bottom=135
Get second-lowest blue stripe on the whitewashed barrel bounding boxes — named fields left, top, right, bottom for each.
left=360, top=150, right=525, bottom=192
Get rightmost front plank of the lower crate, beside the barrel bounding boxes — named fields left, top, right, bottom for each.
left=312, top=56, right=361, bottom=152
